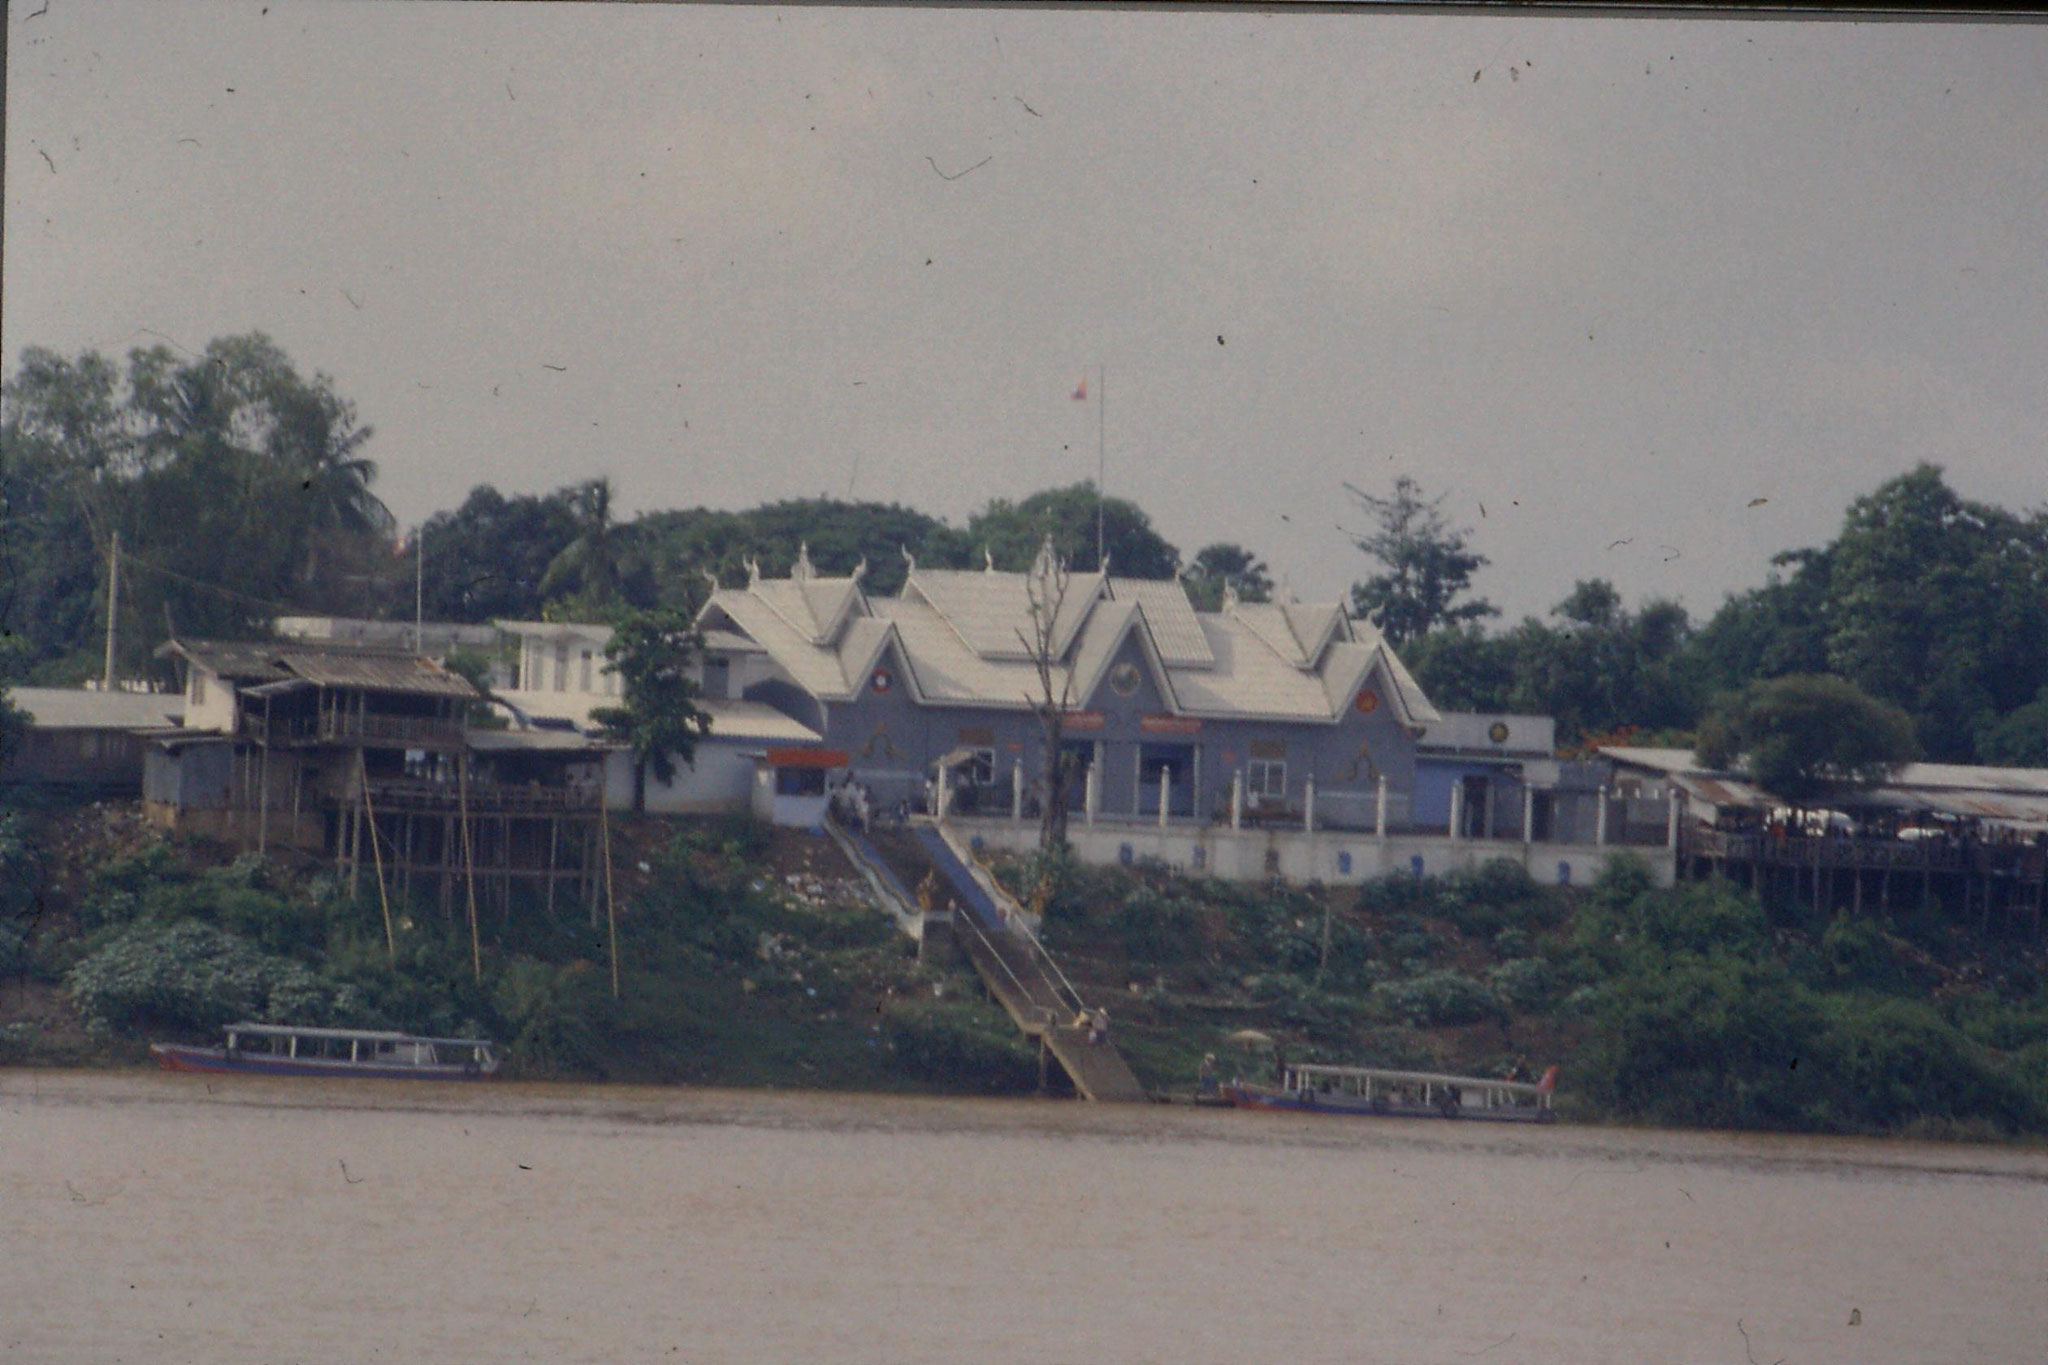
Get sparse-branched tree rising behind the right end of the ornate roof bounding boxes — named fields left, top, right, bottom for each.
left=1343, top=475, right=1499, bottom=645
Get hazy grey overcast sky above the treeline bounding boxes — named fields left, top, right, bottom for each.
left=0, top=0, right=2048, bottom=620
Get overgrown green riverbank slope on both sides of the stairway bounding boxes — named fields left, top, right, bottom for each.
left=0, top=806, right=2048, bottom=1138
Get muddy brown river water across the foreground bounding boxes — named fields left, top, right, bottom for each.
left=0, top=1070, right=2048, bottom=1365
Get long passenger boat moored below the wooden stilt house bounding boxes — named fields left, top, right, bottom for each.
left=150, top=1023, right=498, bottom=1081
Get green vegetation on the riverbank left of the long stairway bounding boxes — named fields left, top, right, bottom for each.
left=0, top=812, right=1038, bottom=1093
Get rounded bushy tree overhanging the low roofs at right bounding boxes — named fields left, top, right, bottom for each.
left=1698, top=673, right=1919, bottom=804
